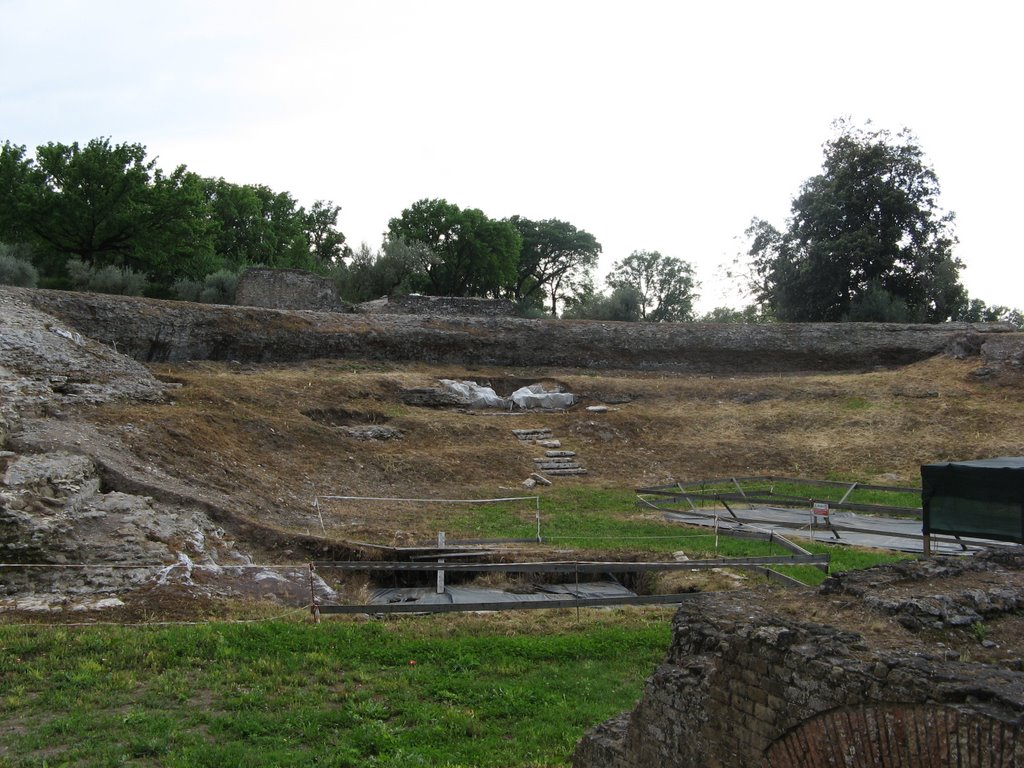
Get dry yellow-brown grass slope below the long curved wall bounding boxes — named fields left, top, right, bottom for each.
left=90, top=357, right=1024, bottom=544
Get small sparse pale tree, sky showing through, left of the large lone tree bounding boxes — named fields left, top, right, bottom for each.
left=605, top=251, right=697, bottom=323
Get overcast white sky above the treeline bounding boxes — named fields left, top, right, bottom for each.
left=0, top=0, right=1024, bottom=309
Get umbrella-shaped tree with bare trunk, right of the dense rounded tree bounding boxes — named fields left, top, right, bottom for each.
left=509, top=216, right=601, bottom=315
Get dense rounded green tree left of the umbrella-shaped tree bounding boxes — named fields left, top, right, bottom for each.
left=387, top=200, right=522, bottom=297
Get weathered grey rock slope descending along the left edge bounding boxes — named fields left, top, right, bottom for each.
left=0, top=291, right=348, bottom=611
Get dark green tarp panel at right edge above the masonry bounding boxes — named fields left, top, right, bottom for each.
left=921, top=457, right=1024, bottom=544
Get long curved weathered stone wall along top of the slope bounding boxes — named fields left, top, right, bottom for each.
left=12, top=289, right=1007, bottom=373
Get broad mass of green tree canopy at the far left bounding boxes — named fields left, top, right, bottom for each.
left=0, top=138, right=346, bottom=294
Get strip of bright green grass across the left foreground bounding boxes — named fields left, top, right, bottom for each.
left=0, top=611, right=670, bottom=767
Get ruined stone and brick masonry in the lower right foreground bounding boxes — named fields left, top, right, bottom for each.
left=573, top=554, right=1024, bottom=768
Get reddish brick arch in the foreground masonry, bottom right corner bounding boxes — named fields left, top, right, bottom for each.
left=764, top=703, right=1024, bottom=768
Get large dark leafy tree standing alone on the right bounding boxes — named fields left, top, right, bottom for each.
left=746, top=122, right=967, bottom=322
